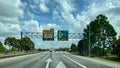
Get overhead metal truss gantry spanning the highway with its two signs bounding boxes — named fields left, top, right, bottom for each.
left=21, top=29, right=82, bottom=41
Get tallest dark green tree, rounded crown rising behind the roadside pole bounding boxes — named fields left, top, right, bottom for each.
left=83, top=14, right=117, bottom=56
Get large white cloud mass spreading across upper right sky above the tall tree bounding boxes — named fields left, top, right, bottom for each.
left=53, top=0, right=120, bottom=35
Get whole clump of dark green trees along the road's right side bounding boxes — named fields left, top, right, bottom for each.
left=71, top=14, right=120, bottom=57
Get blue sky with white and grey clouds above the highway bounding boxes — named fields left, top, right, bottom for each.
left=0, top=0, right=120, bottom=48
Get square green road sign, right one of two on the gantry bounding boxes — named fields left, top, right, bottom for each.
left=58, top=30, right=68, bottom=41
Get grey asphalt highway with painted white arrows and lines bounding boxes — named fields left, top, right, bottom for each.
left=0, top=52, right=116, bottom=68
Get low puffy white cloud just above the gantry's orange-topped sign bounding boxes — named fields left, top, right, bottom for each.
left=22, top=19, right=61, bottom=32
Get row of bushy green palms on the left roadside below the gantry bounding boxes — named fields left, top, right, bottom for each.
left=0, top=37, right=34, bottom=52
